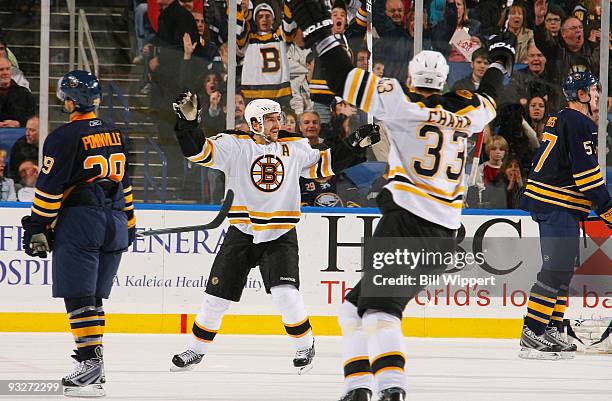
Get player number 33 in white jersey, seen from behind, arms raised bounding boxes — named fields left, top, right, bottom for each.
left=287, top=0, right=516, bottom=401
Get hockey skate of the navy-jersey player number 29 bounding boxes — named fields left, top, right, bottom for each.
left=62, top=358, right=106, bottom=397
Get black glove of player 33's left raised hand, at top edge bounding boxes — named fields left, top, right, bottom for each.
left=285, top=0, right=340, bottom=55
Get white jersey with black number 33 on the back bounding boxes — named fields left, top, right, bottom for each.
left=343, top=68, right=496, bottom=229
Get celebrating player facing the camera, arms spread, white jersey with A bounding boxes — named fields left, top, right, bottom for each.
left=171, top=92, right=380, bottom=374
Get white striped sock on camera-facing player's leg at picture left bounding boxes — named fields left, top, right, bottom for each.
left=189, top=293, right=231, bottom=354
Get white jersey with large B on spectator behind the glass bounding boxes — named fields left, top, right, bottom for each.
left=237, top=6, right=297, bottom=104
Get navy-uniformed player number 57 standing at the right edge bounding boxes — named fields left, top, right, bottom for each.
left=519, top=72, right=612, bottom=359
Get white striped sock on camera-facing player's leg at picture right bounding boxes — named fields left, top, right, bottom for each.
left=270, top=284, right=313, bottom=350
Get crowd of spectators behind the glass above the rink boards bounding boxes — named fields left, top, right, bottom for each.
left=0, top=0, right=612, bottom=208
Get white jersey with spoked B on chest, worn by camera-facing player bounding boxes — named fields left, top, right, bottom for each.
left=184, top=131, right=334, bottom=243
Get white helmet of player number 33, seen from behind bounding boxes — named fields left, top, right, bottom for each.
left=408, top=50, right=449, bottom=90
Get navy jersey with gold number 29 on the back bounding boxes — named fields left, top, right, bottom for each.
left=32, top=113, right=136, bottom=228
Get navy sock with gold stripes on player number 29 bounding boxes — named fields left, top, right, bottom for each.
left=64, top=296, right=104, bottom=360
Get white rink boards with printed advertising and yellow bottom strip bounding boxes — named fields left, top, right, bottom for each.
left=0, top=203, right=612, bottom=338
